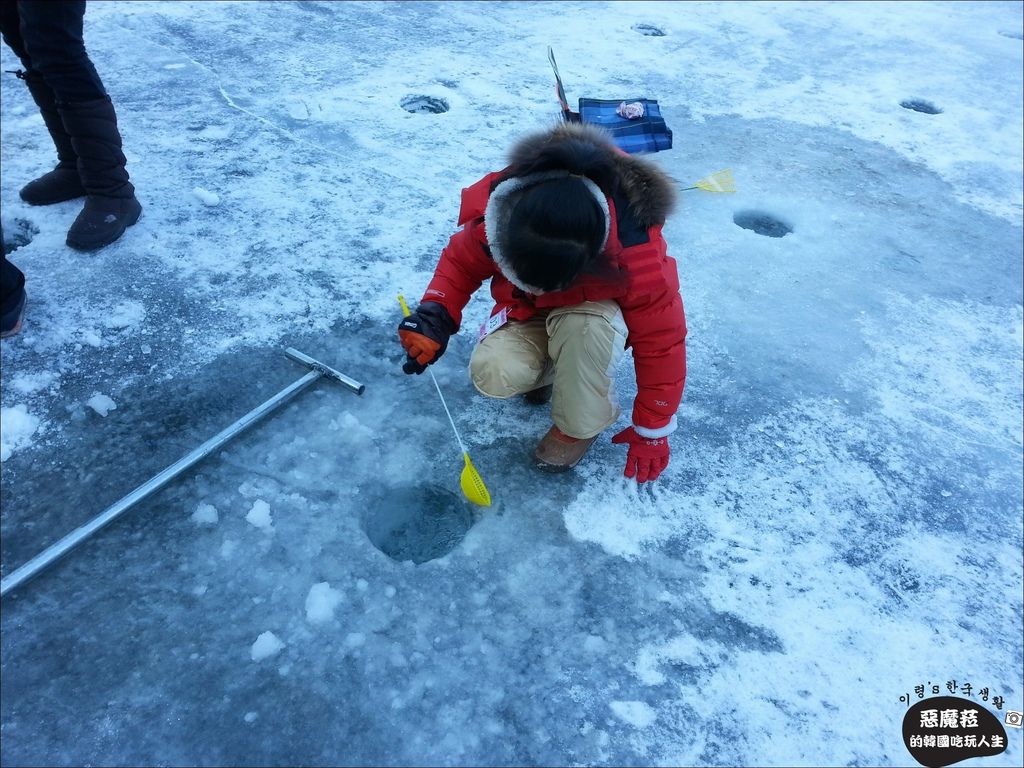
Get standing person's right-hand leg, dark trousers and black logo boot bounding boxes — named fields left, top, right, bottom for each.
left=17, top=0, right=142, bottom=251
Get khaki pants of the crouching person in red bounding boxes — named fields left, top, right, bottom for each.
left=469, top=301, right=627, bottom=438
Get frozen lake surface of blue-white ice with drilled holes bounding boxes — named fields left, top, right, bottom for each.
left=0, top=2, right=1024, bottom=766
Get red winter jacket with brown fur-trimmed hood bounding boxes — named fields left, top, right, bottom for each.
left=422, top=124, right=686, bottom=437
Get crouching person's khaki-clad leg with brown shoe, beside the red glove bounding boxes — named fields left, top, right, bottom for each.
left=534, top=301, right=627, bottom=472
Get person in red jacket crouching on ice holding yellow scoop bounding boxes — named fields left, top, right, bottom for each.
left=398, top=123, right=686, bottom=482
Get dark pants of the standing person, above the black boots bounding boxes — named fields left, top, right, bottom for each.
left=0, top=0, right=106, bottom=104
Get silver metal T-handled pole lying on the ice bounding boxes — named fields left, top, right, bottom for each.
left=0, top=347, right=366, bottom=597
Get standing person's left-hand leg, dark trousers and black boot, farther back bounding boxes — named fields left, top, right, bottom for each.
left=0, top=0, right=85, bottom=206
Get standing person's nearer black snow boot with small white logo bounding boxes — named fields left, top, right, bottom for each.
left=59, top=96, right=142, bottom=251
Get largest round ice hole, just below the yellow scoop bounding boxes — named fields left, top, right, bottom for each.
left=362, top=485, right=473, bottom=565
